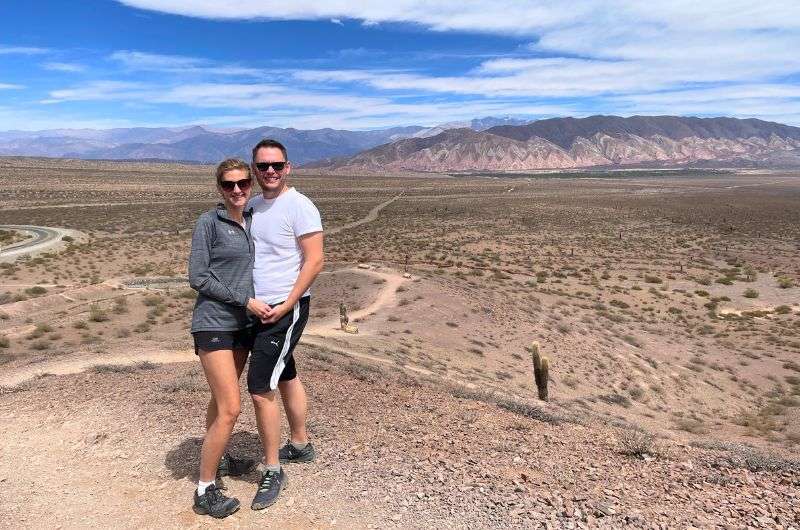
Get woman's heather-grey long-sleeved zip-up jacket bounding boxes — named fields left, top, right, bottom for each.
left=189, top=203, right=255, bottom=333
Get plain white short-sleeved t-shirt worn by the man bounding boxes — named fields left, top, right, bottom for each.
left=248, top=188, right=322, bottom=304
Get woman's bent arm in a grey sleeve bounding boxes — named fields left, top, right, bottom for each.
left=189, top=216, right=250, bottom=307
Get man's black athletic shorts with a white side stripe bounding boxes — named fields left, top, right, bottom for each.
left=247, top=296, right=311, bottom=394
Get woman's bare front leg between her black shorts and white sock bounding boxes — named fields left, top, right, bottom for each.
left=199, top=350, right=241, bottom=482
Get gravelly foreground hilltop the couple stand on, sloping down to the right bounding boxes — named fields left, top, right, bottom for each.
left=0, top=347, right=800, bottom=528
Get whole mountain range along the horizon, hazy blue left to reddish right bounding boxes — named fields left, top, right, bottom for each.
left=0, top=116, right=800, bottom=169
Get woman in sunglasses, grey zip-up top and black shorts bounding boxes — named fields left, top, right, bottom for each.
left=189, top=159, right=268, bottom=518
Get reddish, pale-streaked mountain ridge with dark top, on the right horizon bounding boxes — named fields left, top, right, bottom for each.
left=322, top=116, right=800, bottom=172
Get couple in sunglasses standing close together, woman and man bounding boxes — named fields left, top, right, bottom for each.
left=189, top=139, right=323, bottom=518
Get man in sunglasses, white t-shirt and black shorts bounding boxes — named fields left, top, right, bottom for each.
left=247, top=139, right=323, bottom=510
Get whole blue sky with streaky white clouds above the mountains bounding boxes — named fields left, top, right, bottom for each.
left=0, top=0, right=800, bottom=130
